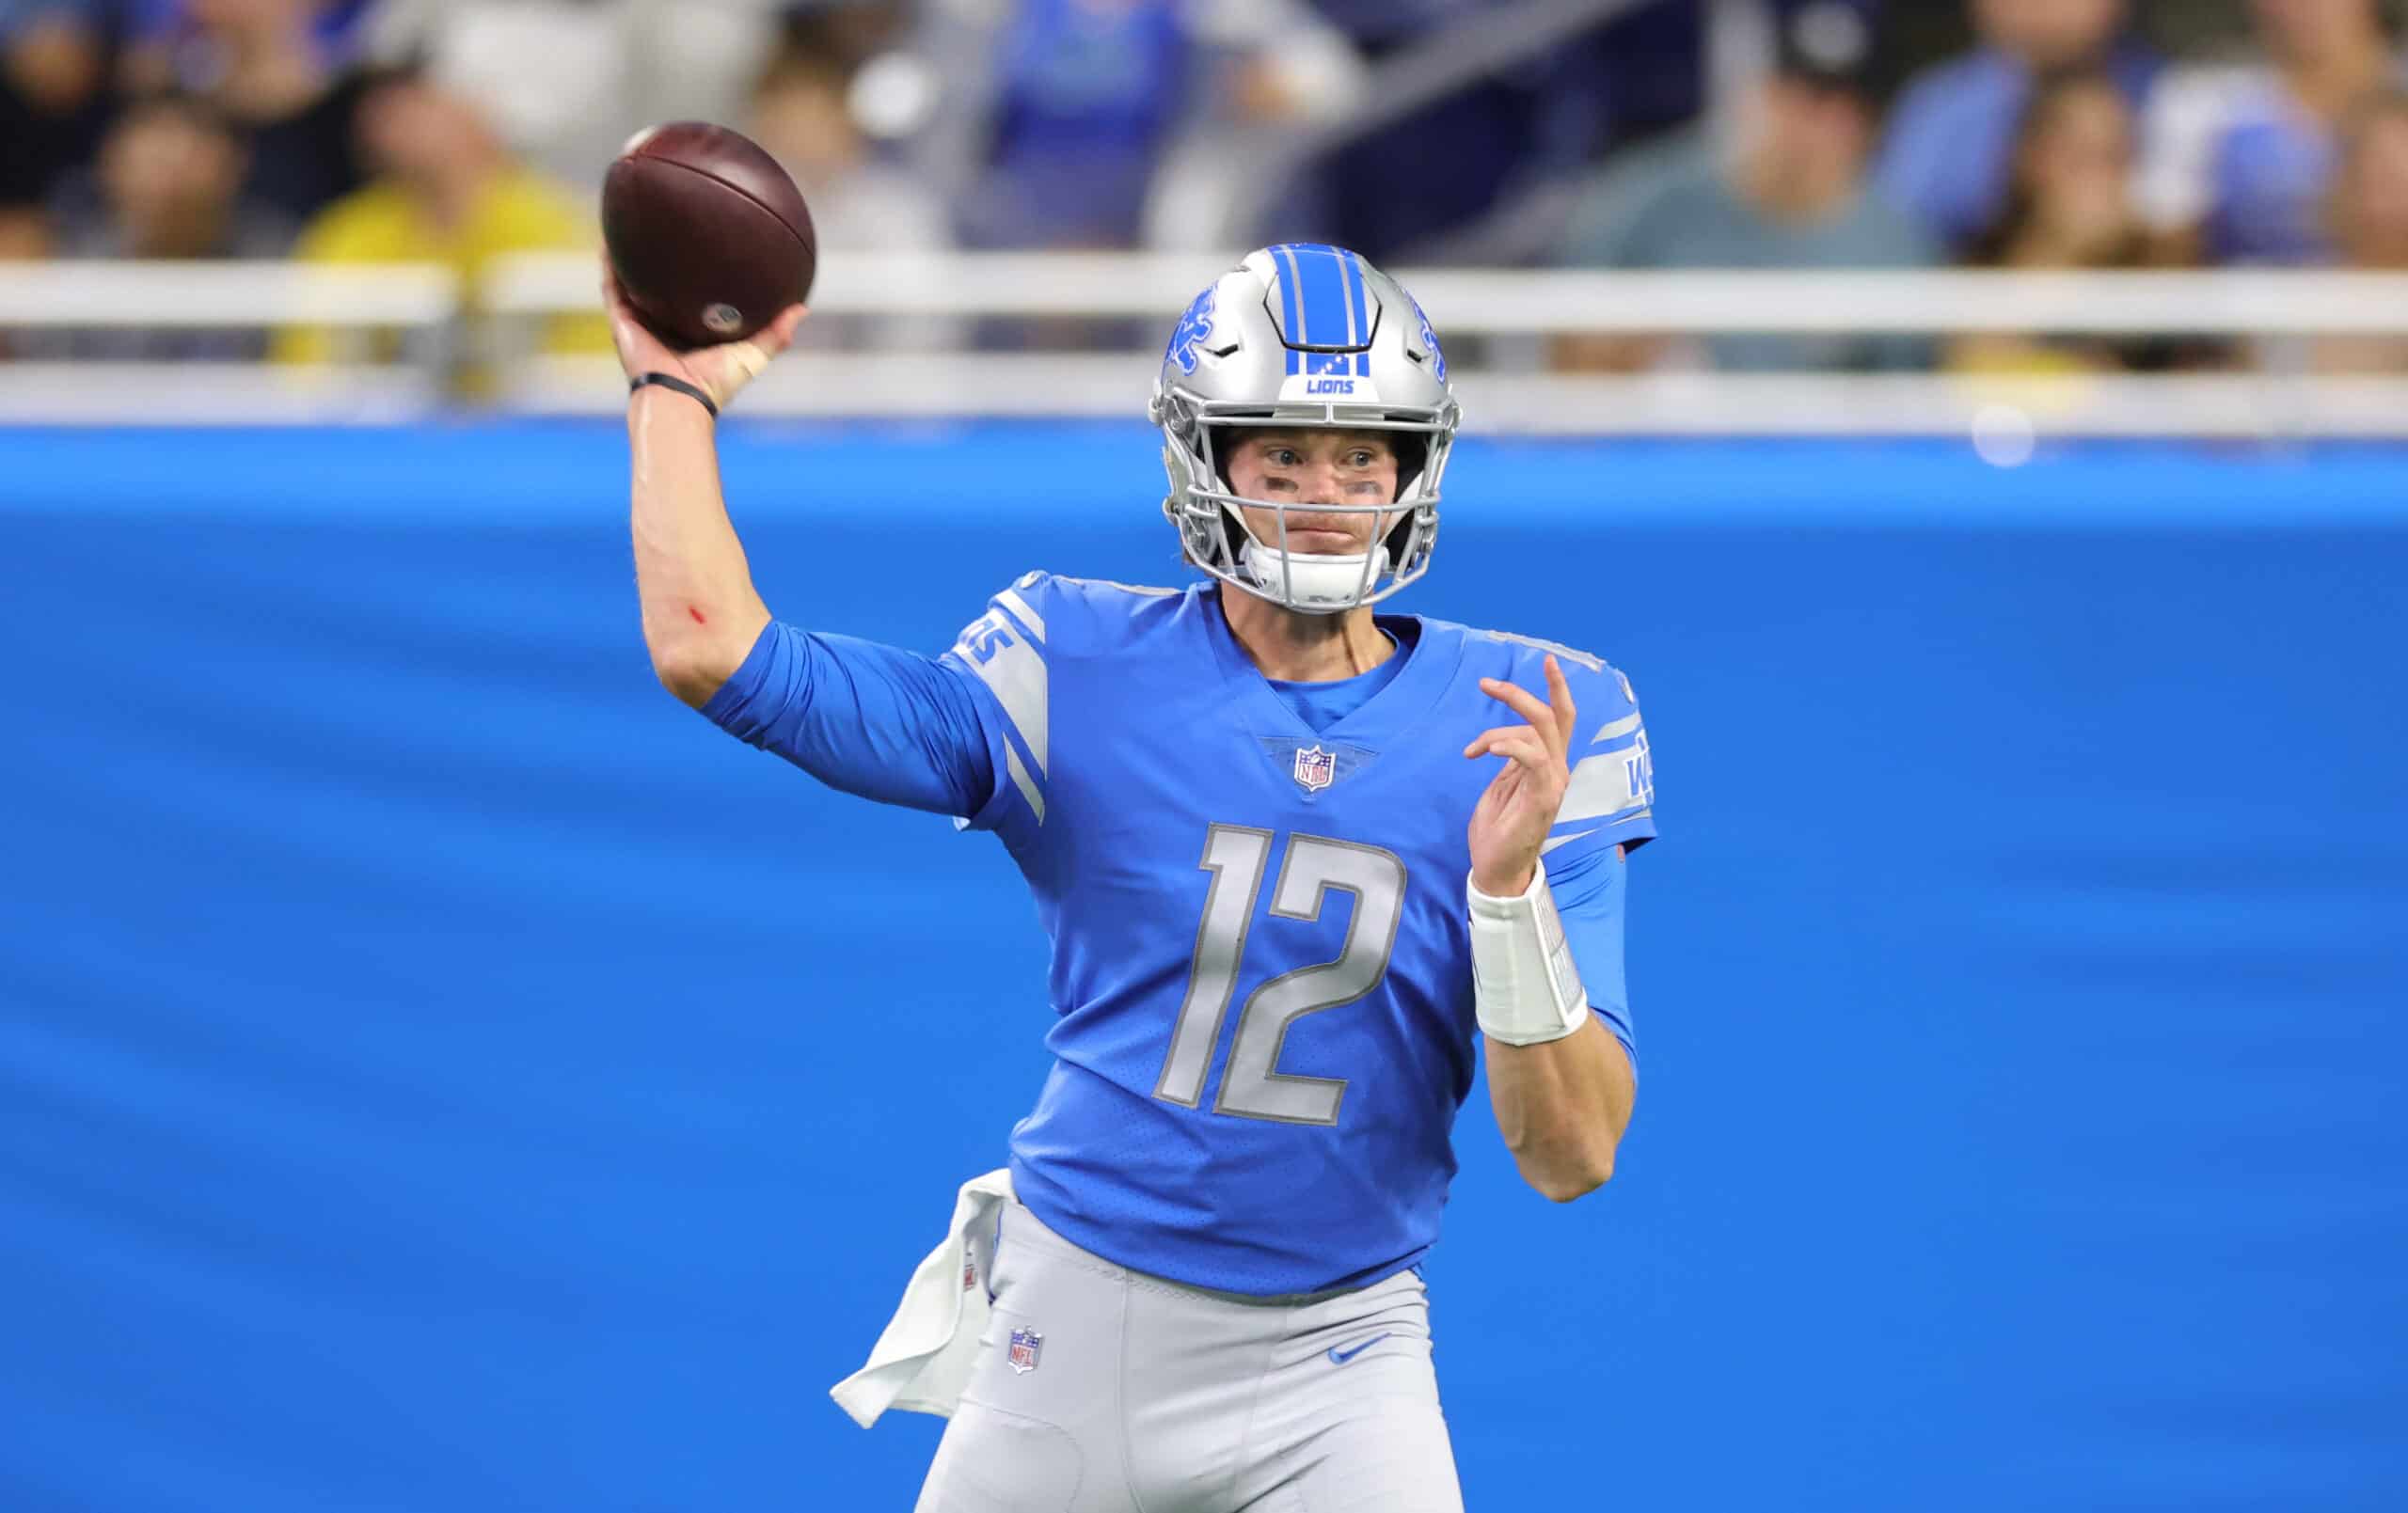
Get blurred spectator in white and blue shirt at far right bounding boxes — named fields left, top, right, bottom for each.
left=2138, top=0, right=2399, bottom=264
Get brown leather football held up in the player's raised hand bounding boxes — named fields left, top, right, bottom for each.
left=602, top=120, right=818, bottom=349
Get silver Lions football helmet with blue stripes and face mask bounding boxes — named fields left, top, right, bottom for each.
left=1147, top=243, right=1462, bottom=613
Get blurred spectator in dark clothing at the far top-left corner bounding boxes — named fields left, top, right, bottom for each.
left=0, top=0, right=113, bottom=258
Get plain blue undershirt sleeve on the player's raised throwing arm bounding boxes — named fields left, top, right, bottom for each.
left=704, top=604, right=1030, bottom=827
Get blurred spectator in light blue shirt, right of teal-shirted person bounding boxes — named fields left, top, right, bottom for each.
left=1874, top=0, right=2160, bottom=250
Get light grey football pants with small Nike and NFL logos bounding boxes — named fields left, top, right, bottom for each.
left=917, top=1203, right=1464, bottom=1513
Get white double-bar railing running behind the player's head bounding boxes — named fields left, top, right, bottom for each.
left=0, top=253, right=2408, bottom=437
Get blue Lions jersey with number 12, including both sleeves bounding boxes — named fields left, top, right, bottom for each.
left=705, top=573, right=1655, bottom=1294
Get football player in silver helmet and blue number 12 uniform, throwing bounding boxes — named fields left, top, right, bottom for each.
left=611, top=243, right=1655, bottom=1513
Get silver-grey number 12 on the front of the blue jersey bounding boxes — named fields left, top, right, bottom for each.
left=1153, top=825, right=1403, bottom=1124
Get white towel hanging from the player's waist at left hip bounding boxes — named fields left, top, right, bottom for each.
left=829, top=1172, right=1011, bottom=1428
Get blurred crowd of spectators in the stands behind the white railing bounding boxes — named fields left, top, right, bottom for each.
left=0, top=0, right=2408, bottom=372
